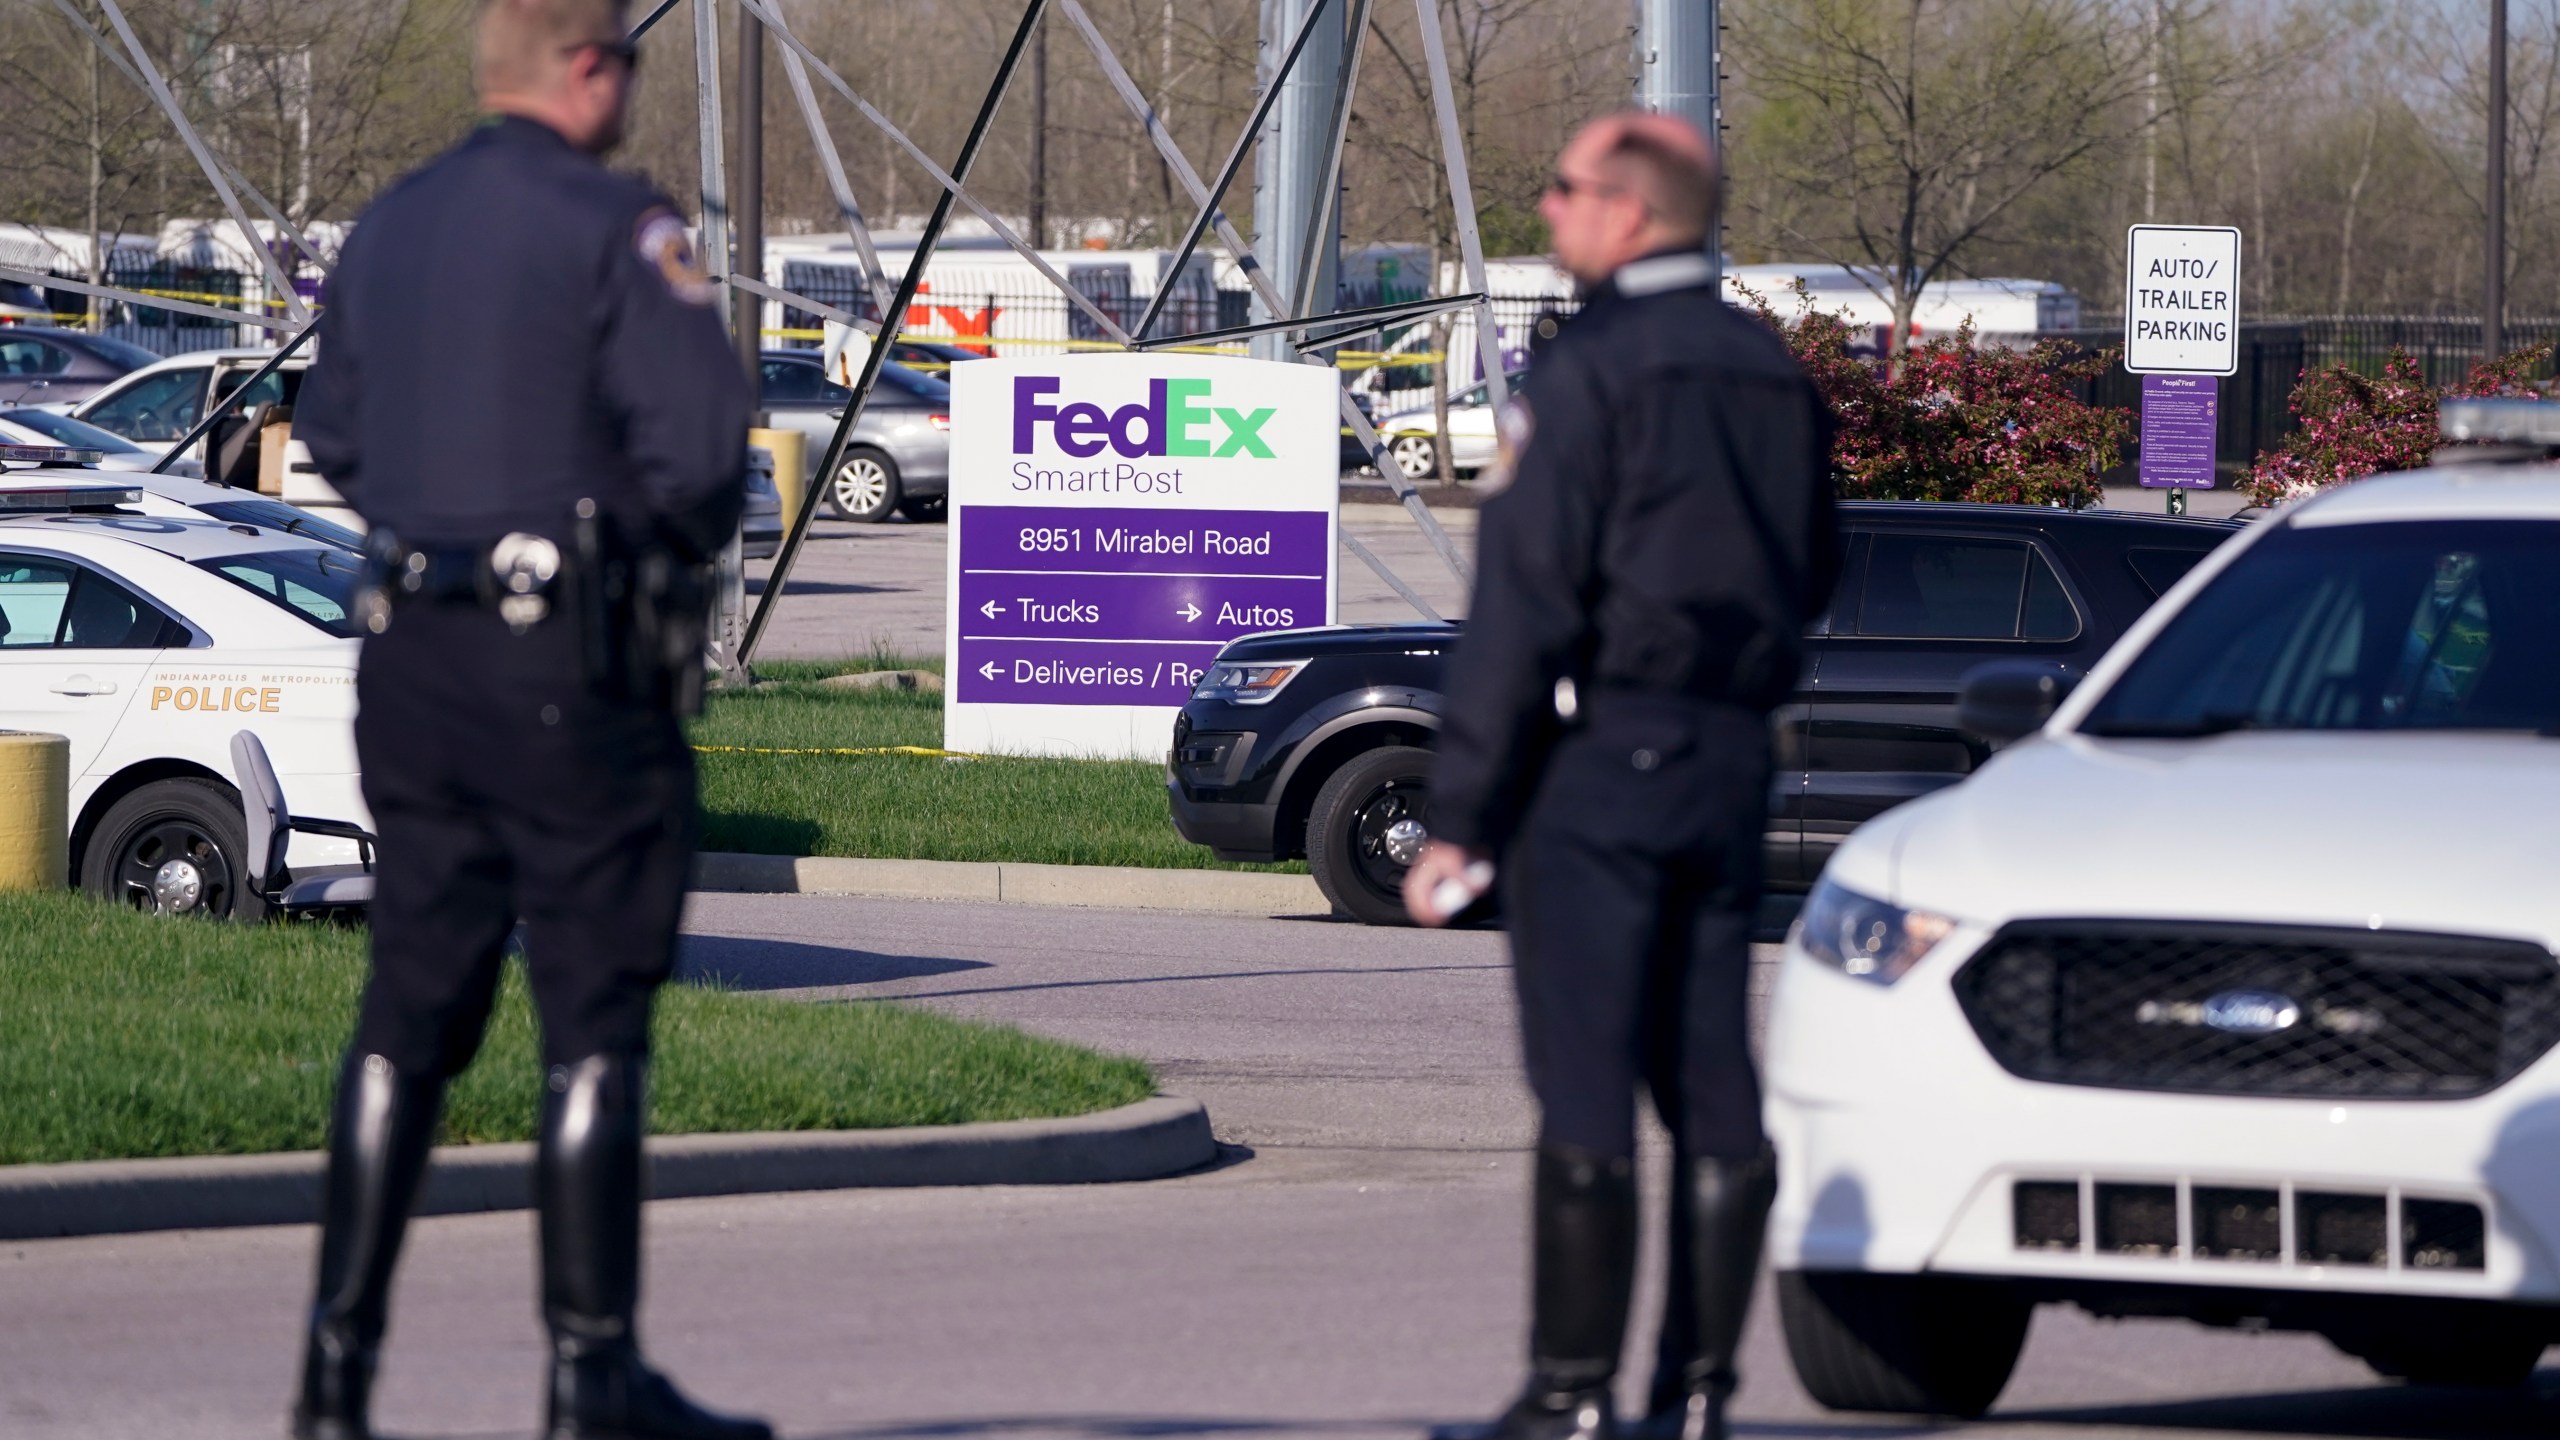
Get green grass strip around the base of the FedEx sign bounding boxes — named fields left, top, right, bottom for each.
left=694, top=659, right=1306, bottom=871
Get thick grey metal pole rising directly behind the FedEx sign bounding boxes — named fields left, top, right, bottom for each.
left=1254, top=0, right=1344, bottom=361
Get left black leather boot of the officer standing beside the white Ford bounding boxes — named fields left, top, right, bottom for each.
left=1443, top=1145, right=1636, bottom=1440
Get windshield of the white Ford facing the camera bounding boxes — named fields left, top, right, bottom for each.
left=2079, top=520, right=2560, bottom=735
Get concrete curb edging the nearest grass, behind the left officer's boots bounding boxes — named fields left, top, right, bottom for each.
left=0, top=1094, right=1219, bottom=1240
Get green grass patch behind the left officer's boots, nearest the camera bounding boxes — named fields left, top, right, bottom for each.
left=0, top=894, right=1155, bottom=1163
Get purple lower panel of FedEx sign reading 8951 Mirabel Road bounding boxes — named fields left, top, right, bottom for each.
left=952, top=505, right=1334, bottom=705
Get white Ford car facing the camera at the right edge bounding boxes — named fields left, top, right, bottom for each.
left=1769, top=464, right=2560, bottom=1414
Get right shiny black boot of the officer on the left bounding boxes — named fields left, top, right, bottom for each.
left=535, top=1056, right=773, bottom=1440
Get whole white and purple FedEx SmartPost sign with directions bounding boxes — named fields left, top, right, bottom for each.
left=942, top=356, right=1341, bottom=758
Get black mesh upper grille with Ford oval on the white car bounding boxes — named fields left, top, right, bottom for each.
left=1956, top=920, right=2560, bottom=1099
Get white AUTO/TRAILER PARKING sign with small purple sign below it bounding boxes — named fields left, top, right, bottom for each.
left=2125, top=225, right=2240, bottom=515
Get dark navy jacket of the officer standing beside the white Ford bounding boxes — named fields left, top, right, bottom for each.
left=1431, top=251, right=1838, bottom=848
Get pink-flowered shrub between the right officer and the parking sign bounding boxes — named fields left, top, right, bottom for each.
left=1743, top=284, right=2132, bottom=507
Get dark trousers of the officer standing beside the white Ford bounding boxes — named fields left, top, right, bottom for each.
left=1503, top=692, right=1769, bottom=1161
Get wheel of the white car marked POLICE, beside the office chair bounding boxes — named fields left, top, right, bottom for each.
left=79, top=779, right=266, bottom=920
